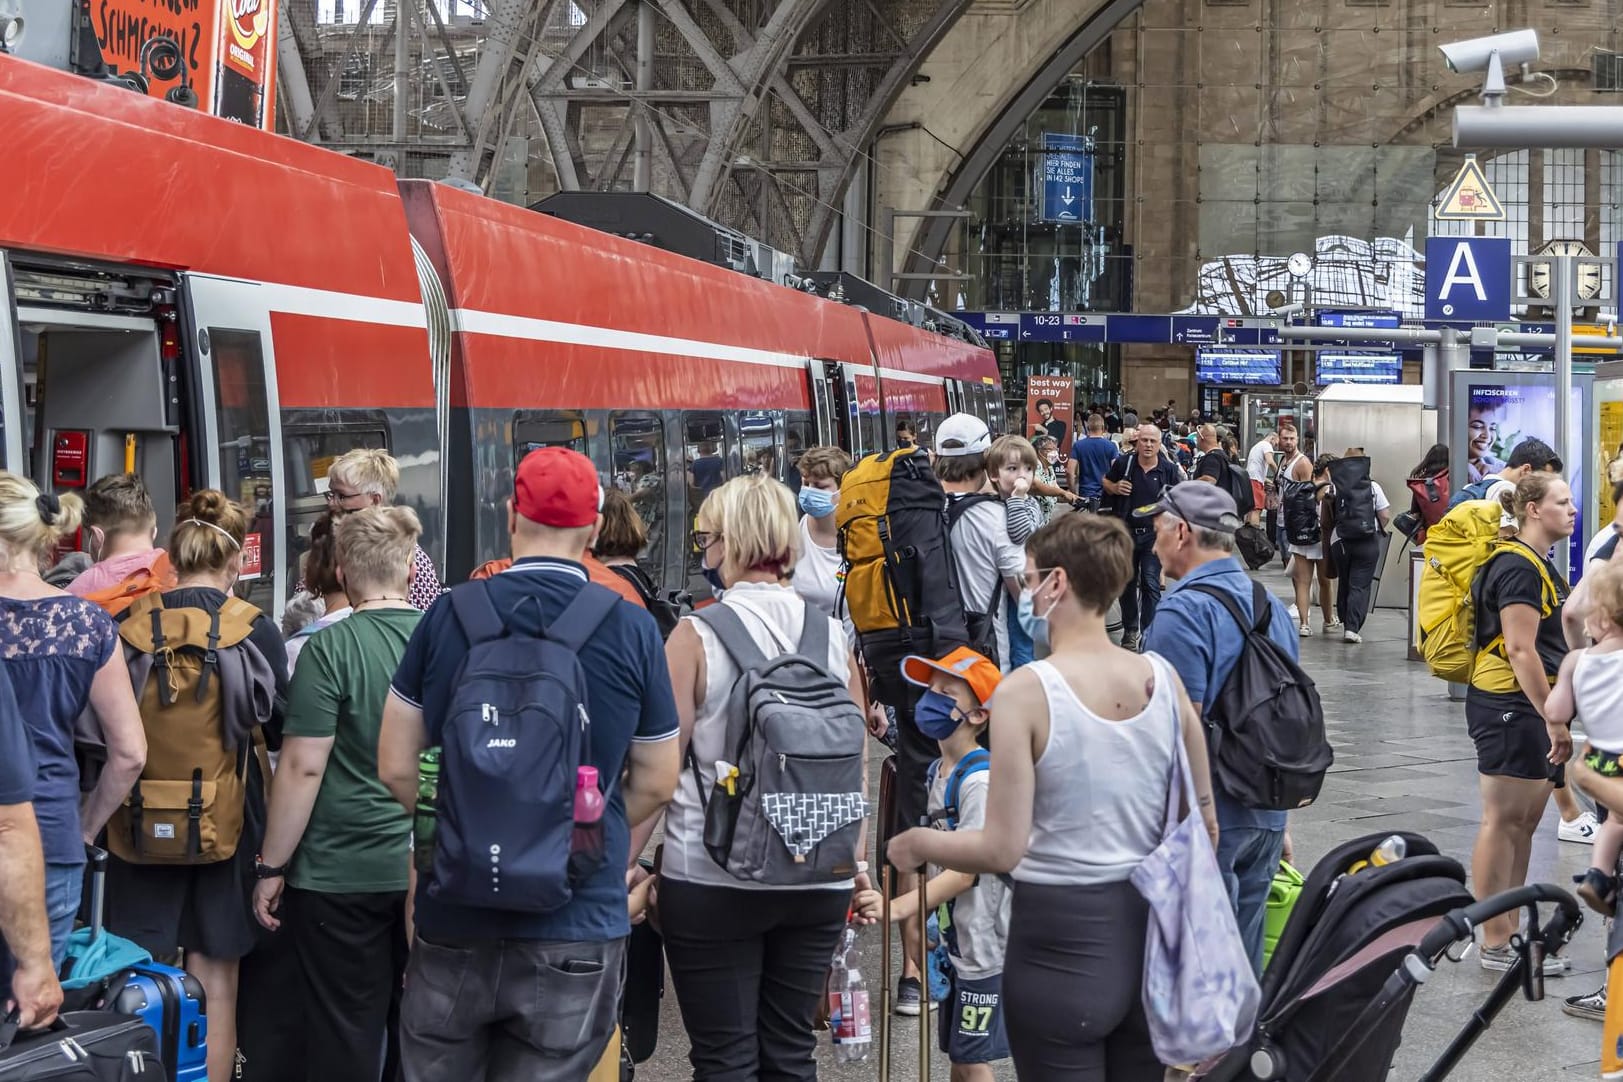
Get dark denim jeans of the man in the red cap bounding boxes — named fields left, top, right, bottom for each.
left=401, top=934, right=625, bottom=1082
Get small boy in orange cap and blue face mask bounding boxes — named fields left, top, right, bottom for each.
left=857, top=647, right=1010, bottom=1082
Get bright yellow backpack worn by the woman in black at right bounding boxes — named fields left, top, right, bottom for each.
left=1415, top=500, right=1560, bottom=689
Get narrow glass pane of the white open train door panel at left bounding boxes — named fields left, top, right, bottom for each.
left=208, top=328, right=278, bottom=612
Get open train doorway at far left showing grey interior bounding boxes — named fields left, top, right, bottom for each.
left=0, top=253, right=195, bottom=543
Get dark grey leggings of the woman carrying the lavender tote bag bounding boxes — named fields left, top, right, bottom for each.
left=1003, top=881, right=1165, bottom=1082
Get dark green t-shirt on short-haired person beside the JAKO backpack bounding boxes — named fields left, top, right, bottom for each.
left=282, top=608, right=422, bottom=894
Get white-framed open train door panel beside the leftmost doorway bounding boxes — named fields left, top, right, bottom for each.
left=182, top=274, right=291, bottom=623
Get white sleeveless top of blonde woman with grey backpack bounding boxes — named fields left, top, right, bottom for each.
left=661, top=582, right=855, bottom=891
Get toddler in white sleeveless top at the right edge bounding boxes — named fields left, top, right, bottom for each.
left=1543, top=563, right=1623, bottom=917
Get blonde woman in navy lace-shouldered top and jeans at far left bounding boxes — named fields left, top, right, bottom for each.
left=0, top=470, right=146, bottom=967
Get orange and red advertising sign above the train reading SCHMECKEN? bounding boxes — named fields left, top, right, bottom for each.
left=91, top=0, right=276, bottom=130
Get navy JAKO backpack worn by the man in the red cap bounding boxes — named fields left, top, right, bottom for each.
left=427, top=581, right=620, bottom=913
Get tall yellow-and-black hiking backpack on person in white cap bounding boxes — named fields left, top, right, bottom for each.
left=836, top=448, right=969, bottom=706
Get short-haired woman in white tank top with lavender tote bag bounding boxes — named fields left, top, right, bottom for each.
left=888, top=514, right=1217, bottom=1082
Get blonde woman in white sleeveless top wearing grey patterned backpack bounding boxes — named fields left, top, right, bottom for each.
left=655, top=476, right=865, bottom=1079
